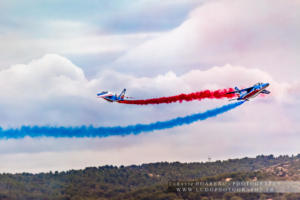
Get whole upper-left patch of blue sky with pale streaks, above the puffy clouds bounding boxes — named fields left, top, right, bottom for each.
left=0, top=0, right=201, bottom=76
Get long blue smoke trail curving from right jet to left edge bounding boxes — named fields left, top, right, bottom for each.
left=0, top=101, right=244, bottom=139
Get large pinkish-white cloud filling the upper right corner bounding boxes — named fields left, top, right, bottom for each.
left=112, top=0, right=300, bottom=80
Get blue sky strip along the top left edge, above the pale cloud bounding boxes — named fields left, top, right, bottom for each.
left=2, top=0, right=200, bottom=34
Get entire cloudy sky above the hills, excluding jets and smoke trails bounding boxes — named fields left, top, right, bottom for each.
left=0, top=0, right=300, bottom=173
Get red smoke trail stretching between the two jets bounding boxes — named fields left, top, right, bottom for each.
left=119, top=88, right=236, bottom=105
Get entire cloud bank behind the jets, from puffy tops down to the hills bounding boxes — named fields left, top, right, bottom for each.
left=0, top=55, right=300, bottom=172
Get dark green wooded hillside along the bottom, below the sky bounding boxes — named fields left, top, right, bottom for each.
left=0, top=154, right=300, bottom=200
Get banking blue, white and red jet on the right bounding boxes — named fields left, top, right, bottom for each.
left=227, top=83, right=271, bottom=101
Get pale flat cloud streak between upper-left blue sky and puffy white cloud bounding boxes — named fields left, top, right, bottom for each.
left=0, top=20, right=160, bottom=71
